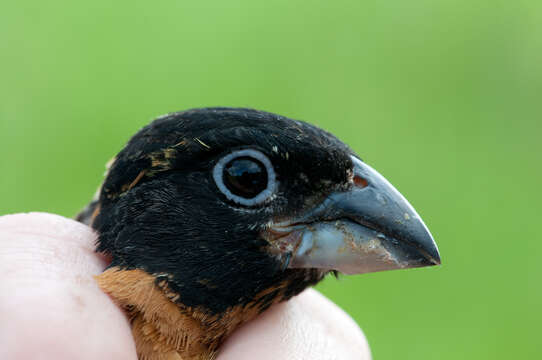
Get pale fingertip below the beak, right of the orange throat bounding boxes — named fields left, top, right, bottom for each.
left=218, top=289, right=371, bottom=360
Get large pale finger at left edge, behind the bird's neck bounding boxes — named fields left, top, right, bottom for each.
left=0, top=213, right=136, bottom=360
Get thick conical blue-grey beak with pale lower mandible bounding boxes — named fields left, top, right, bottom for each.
left=269, top=157, right=440, bottom=274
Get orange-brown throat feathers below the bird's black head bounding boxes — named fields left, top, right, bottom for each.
left=96, top=267, right=282, bottom=360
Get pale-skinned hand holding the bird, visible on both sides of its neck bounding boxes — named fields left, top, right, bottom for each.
left=0, top=213, right=371, bottom=360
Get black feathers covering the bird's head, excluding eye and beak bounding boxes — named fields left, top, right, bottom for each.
left=92, top=108, right=360, bottom=313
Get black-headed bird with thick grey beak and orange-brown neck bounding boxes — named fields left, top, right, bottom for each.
left=76, top=107, right=440, bottom=360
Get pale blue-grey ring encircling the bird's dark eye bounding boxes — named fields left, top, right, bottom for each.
left=213, top=149, right=278, bottom=206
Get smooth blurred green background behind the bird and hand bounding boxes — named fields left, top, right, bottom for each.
left=0, top=0, right=542, bottom=360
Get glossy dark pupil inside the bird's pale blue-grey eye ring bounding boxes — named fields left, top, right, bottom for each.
left=224, top=157, right=267, bottom=199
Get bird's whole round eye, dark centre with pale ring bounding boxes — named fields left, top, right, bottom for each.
left=213, top=149, right=277, bottom=206
